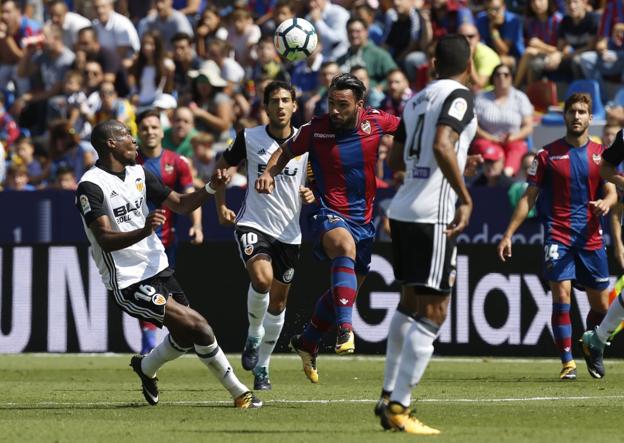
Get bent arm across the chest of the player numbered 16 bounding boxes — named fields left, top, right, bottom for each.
left=89, top=209, right=165, bottom=252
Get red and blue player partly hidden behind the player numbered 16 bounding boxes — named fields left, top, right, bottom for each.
left=137, top=110, right=204, bottom=354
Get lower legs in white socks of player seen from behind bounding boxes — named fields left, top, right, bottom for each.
left=375, top=286, right=450, bottom=435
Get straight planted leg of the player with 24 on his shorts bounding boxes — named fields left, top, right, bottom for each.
left=549, top=280, right=576, bottom=380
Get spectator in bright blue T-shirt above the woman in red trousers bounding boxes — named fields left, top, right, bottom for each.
left=476, top=0, right=524, bottom=66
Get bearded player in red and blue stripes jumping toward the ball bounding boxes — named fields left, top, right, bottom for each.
left=256, top=74, right=400, bottom=383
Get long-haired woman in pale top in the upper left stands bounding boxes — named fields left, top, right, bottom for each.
left=128, top=29, right=174, bottom=112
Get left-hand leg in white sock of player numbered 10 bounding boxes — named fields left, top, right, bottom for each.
left=241, top=254, right=273, bottom=371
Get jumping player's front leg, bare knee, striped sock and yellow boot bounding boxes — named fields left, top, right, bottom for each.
left=321, top=228, right=358, bottom=354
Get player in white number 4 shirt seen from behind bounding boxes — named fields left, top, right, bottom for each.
left=375, top=35, right=477, bottom=435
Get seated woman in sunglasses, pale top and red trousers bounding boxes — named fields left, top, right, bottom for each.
left=472, top=64, right=533, bottom=176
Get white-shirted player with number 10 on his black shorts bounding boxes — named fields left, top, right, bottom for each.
left=215, top=81, right=314, bottom=390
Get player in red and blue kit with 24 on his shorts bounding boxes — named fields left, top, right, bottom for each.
left=498, top=93, right=617, bottom=380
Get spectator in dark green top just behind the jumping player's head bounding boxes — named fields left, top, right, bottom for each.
left=336, top=18, right=397, bottom=91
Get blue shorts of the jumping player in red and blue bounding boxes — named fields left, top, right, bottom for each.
left=310, top=208, right=375, bottom=275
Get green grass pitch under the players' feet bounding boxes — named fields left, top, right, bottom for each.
left=0, top=355, right=624, bottom=443
